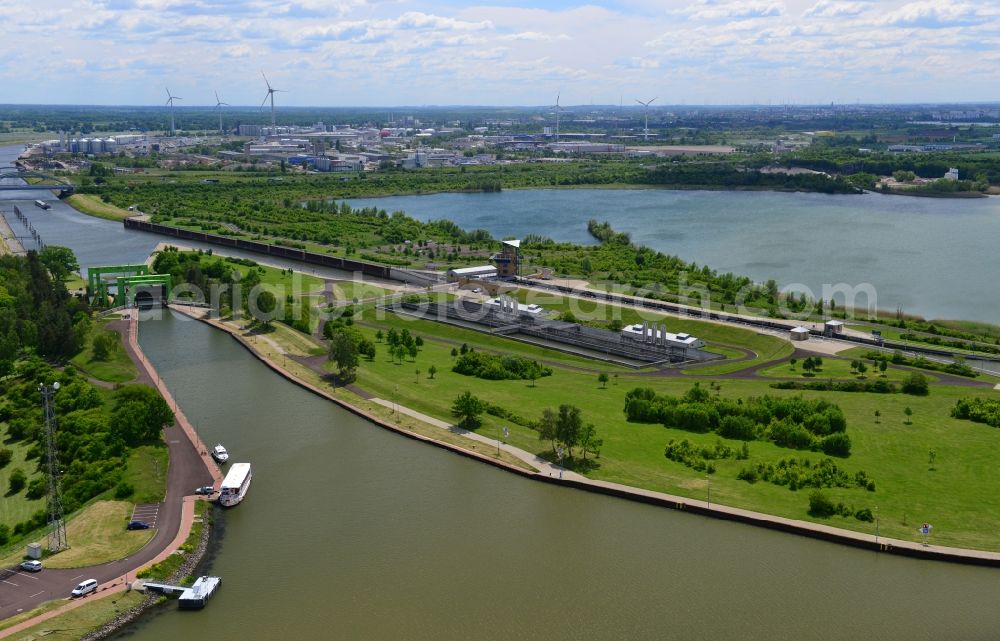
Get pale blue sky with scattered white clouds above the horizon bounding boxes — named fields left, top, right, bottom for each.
left=0, top=0, right=1000, bottom=106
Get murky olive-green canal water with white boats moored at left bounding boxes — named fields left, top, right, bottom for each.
left=1, top=146, right=1000, bottom=641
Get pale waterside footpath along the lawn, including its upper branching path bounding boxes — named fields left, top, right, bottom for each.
left=171, top=305, right=1000, bottom=567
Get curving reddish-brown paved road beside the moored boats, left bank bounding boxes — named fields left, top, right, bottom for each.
left=0, top=321, right=215, bottom=619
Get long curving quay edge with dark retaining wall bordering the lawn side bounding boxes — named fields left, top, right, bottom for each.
left=170, top=305, right=1000, bottom=567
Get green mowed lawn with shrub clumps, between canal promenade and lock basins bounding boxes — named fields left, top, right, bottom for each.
left=318, top=304, right=1000, bottom=550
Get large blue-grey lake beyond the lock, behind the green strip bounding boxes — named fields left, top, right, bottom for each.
left=350, top=189, right=1000, bottom=322
